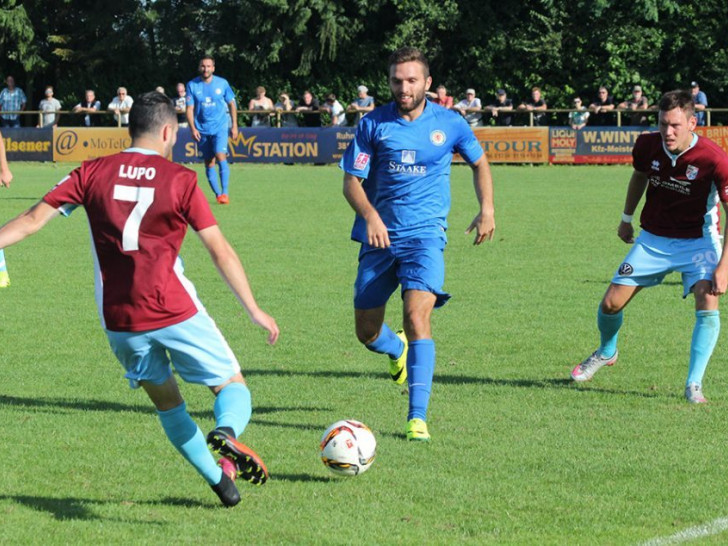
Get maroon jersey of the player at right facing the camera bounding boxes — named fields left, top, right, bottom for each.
left=632, top=133, right=728, bottom=239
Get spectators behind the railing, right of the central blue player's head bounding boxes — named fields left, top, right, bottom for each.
left=428, top=81, right=708, bottom=129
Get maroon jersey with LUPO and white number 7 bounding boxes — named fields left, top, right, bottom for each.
left=43, top=148, right=217, bottom=332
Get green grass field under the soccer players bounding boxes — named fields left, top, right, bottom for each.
left=0, top=164, right=728, bottom=545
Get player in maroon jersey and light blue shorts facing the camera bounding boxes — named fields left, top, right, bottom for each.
left=571, top=91, right=728, bottom=404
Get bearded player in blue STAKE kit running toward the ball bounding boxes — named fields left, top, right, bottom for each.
left=340, top=47, right=495, bottom=441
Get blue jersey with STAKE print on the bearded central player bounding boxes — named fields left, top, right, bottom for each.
left=339, top=101, right=483, bottom=243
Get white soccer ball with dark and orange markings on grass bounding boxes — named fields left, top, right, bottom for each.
left=321, top=419, right=377, bottom=476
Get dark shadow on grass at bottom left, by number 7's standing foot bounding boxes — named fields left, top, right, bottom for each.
left=0, top=495, right=220, bottom=526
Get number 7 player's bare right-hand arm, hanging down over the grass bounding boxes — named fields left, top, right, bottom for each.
left=197, top=226, right=280, bottom=345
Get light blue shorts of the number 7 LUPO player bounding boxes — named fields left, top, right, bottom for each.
left=106, top=311, right=240, bottom=389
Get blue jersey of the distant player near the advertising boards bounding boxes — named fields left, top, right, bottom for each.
left=187, top=76, right=235, bottom=135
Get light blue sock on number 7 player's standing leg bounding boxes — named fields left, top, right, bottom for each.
left=157, top=402, right=222, bottom=485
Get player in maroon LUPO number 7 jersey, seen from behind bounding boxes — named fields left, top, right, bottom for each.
left=0, top=92, right=279, bottom=506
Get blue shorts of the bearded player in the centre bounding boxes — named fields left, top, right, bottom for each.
left=354, top=238, right=450, bottom=309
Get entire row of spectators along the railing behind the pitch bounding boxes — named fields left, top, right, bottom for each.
left=0, top=76, right=708, bottom=129
